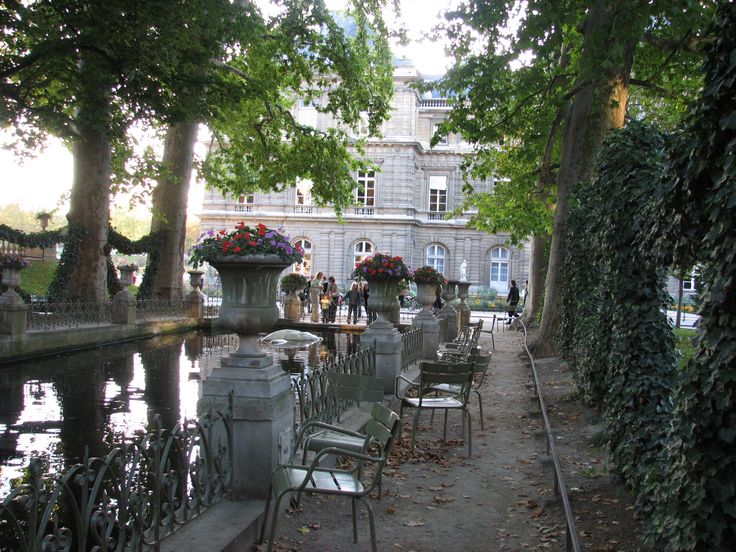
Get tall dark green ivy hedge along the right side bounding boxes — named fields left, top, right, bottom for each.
left=560, top=3, right=736, bottom=552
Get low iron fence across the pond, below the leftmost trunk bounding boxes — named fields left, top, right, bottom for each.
left=28, top=300, right=112, bottom=330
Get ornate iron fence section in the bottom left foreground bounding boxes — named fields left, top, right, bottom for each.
left=0, top=411, right=233, bottom=552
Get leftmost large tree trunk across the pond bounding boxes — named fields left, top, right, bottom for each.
left=64, top=55, right=111, bottom=302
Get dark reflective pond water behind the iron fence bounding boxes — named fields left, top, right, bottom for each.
left=0, top=332, right=360, bottom=498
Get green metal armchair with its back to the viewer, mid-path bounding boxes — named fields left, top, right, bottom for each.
left=395, top=361, right=473, bottom=455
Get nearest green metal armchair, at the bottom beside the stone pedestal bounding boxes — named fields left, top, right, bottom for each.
left=259, top=406, right=401, bottom=552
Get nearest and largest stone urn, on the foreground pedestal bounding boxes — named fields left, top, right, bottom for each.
left=210, top=255, right=291, bottom=368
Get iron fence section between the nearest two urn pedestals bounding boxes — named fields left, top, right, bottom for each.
left=291, top=347, right=376, bottom=436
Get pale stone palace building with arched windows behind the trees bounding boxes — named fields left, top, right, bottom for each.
left=199, top=61, right=530, bottom=295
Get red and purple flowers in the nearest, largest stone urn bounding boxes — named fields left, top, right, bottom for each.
left=189, top=222, right=303, bottom=268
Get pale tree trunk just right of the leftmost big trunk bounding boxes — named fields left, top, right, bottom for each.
left=151, top=123, right=198, bottom=299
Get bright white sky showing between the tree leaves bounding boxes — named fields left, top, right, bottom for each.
left=0, top=0, right=456, bottom=216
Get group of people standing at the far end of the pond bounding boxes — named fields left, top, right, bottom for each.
left=300, top=272, right=376, bottom=324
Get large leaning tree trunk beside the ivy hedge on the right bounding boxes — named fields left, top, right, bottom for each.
left=535, top=0, right=638, bottom=357
